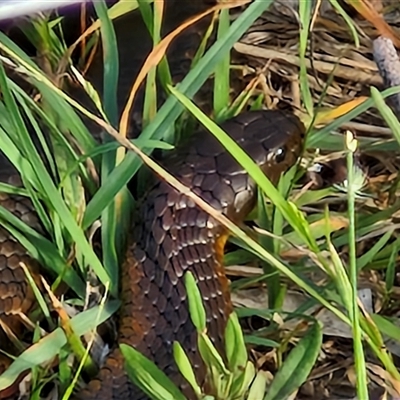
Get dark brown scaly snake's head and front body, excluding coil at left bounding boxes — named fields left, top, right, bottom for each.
left=76, top=111, right=304, bottom=400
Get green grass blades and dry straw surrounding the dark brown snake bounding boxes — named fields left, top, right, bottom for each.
left=0, top=0, right=400, bottom=400
